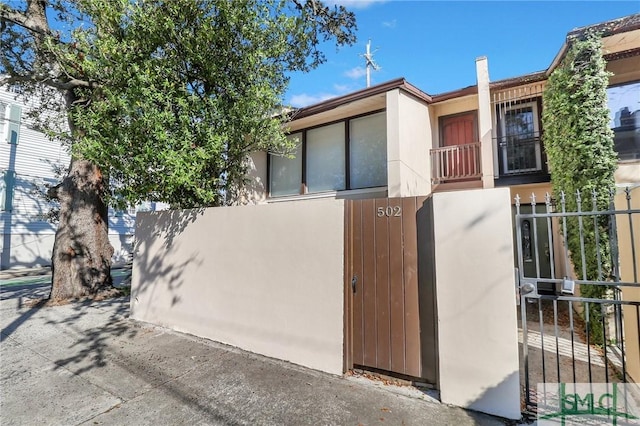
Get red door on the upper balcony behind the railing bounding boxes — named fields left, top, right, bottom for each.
left=440, top=112, right=479, bottom=180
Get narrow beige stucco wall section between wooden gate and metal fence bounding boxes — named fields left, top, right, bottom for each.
left=431, top=188, right=520, bottom=419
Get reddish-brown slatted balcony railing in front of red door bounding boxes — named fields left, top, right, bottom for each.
left=431, top=142, right=482, bottom=184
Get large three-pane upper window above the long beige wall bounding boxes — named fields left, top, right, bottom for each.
left=269, top=112, right=387, bottom=197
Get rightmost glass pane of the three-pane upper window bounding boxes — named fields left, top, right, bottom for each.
left=349, top=113, right=387, bottom=189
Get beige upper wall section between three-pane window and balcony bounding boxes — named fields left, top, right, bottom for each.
left=387, top=89, right=431, bottom=197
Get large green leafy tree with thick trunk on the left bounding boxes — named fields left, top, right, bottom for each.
left=0, top=0, right=356, bottom=299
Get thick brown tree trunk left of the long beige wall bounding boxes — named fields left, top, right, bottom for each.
left=49, top=160, right=113, bottom=300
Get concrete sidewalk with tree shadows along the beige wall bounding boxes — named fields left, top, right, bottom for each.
left=0, top=285, right=504, bottom=426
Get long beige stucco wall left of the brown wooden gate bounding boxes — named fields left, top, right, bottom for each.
left=131, top=199, right=344, bottom=374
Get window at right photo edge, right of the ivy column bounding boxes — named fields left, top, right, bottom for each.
left=607, top=81, right=640, bottom=160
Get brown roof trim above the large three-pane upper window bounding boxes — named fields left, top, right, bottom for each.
left=289, top=78, right=432, bottom=120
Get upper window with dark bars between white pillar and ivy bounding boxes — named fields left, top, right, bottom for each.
left=499, top=102, right=542, bottom=174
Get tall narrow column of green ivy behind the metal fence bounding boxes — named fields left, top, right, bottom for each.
left=542, top=34, right=617, bottom=343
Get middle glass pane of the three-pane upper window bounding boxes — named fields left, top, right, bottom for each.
left=307, top=123, right=345, bottom=192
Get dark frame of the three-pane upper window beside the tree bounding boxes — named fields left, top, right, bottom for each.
left=266, top=108, right=388, bottom=199
